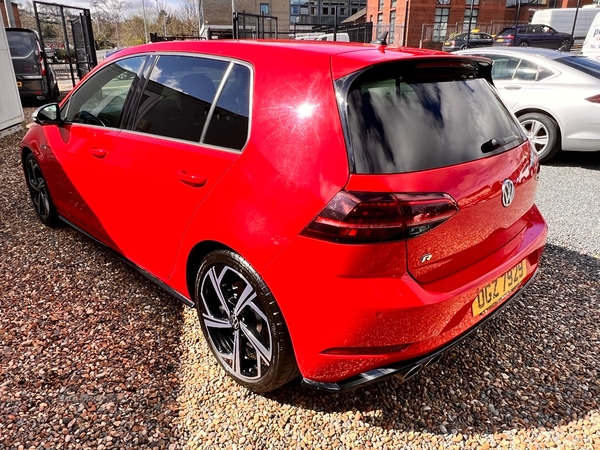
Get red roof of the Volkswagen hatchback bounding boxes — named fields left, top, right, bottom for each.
left=103, top=39, right=474, bottom=78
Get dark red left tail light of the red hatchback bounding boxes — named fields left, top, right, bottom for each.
left=302, top=191, right=459, bottom=244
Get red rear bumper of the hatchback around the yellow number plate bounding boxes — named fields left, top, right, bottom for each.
left=263, top=206, right=547, bottom=384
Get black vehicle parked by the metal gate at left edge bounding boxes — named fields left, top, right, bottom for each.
left=6, top=28, right=60, bottom=102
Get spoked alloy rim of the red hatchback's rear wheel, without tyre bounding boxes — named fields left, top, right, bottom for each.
left=200, top=264, right=273, bottom=381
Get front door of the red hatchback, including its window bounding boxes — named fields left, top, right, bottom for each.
left=44, top=56, right=146, bottom=250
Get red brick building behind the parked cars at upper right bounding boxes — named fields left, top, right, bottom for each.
left=367, top=0, right=593, bottom=49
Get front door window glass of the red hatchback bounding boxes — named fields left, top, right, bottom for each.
left=61, top=56, right=146, bottom=128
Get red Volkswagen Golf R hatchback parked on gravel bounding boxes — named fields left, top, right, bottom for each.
left=22, top=41, right=547, bottom=392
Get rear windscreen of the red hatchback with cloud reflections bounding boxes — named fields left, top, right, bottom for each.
left=338, top=59, right=525, bottom=174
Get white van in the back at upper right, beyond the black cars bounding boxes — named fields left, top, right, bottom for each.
left=531, top=4, right=600, bottom=39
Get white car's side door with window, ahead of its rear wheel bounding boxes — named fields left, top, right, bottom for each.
left=481, top=53, right=537, bottom=109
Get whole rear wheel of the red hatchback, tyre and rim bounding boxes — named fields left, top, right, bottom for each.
left=195, top=250, right=299, bottom=393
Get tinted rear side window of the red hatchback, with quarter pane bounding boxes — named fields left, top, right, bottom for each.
left=134, top=55, right=250, bottom=150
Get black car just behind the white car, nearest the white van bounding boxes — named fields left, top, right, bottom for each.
left=493, top=24, right=573, bottom=52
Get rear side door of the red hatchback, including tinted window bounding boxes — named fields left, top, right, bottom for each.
left=88, top=54, right=250, bottom=280
